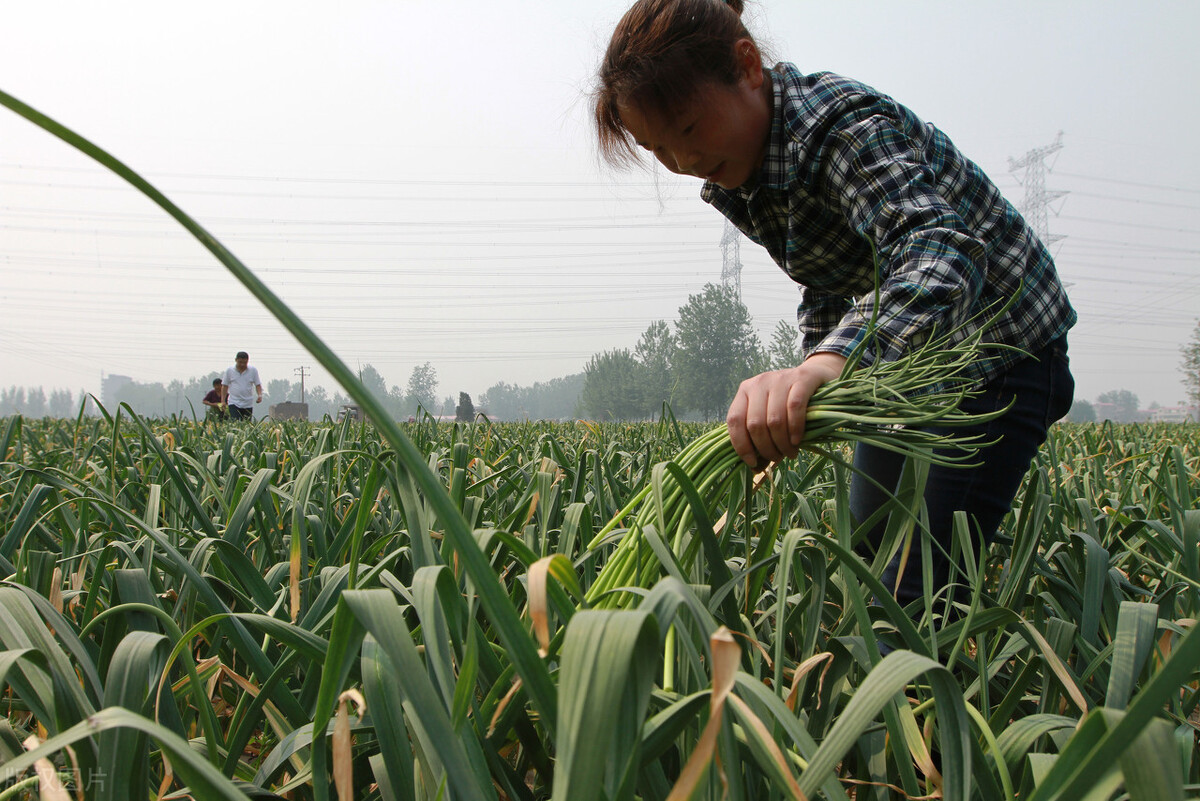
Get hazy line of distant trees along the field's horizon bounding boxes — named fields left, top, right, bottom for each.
left=7, top=304, right=1200, bottom=422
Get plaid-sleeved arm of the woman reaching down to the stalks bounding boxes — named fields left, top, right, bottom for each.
left=802, top=107, right=988, bottom=361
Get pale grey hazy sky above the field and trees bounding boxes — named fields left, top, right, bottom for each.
left=0, top=0, right=1200, bottom=405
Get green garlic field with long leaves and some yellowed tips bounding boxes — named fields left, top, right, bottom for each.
left=0, top=409, right=1200, bottom=801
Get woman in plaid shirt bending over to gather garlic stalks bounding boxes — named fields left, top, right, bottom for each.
left=594, top=0, right=1075, bottom=604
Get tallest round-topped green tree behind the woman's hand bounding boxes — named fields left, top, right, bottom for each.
left=674, top=284, right=761, bottom=417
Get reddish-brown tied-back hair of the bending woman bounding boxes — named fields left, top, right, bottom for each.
left=594, top=0, right=754, bottom=164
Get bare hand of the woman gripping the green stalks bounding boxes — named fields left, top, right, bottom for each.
left=725, top=353, right=846, bottom=466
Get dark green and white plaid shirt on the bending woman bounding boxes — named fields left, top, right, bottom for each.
left=701, top=64, right=1075, bottom=380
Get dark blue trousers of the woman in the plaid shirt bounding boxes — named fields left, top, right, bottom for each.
left=850, top=336, right=1075, bottom=606
